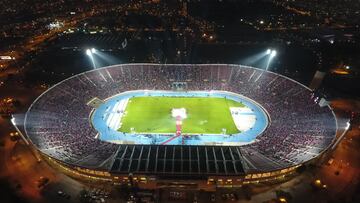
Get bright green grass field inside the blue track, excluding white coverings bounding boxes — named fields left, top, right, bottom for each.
left=119, top=97, right=244, bottom=134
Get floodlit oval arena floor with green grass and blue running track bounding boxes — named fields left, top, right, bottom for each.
left=91, top=90, right=268, bottom=145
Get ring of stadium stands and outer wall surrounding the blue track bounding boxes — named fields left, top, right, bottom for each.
left=19, top=64, right=337, bottom=188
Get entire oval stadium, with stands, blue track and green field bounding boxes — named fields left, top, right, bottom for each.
left=24, top=64, right=337, bottom=186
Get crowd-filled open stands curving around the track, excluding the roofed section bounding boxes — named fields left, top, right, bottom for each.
left=25, top=64, right=336, bottom=171
